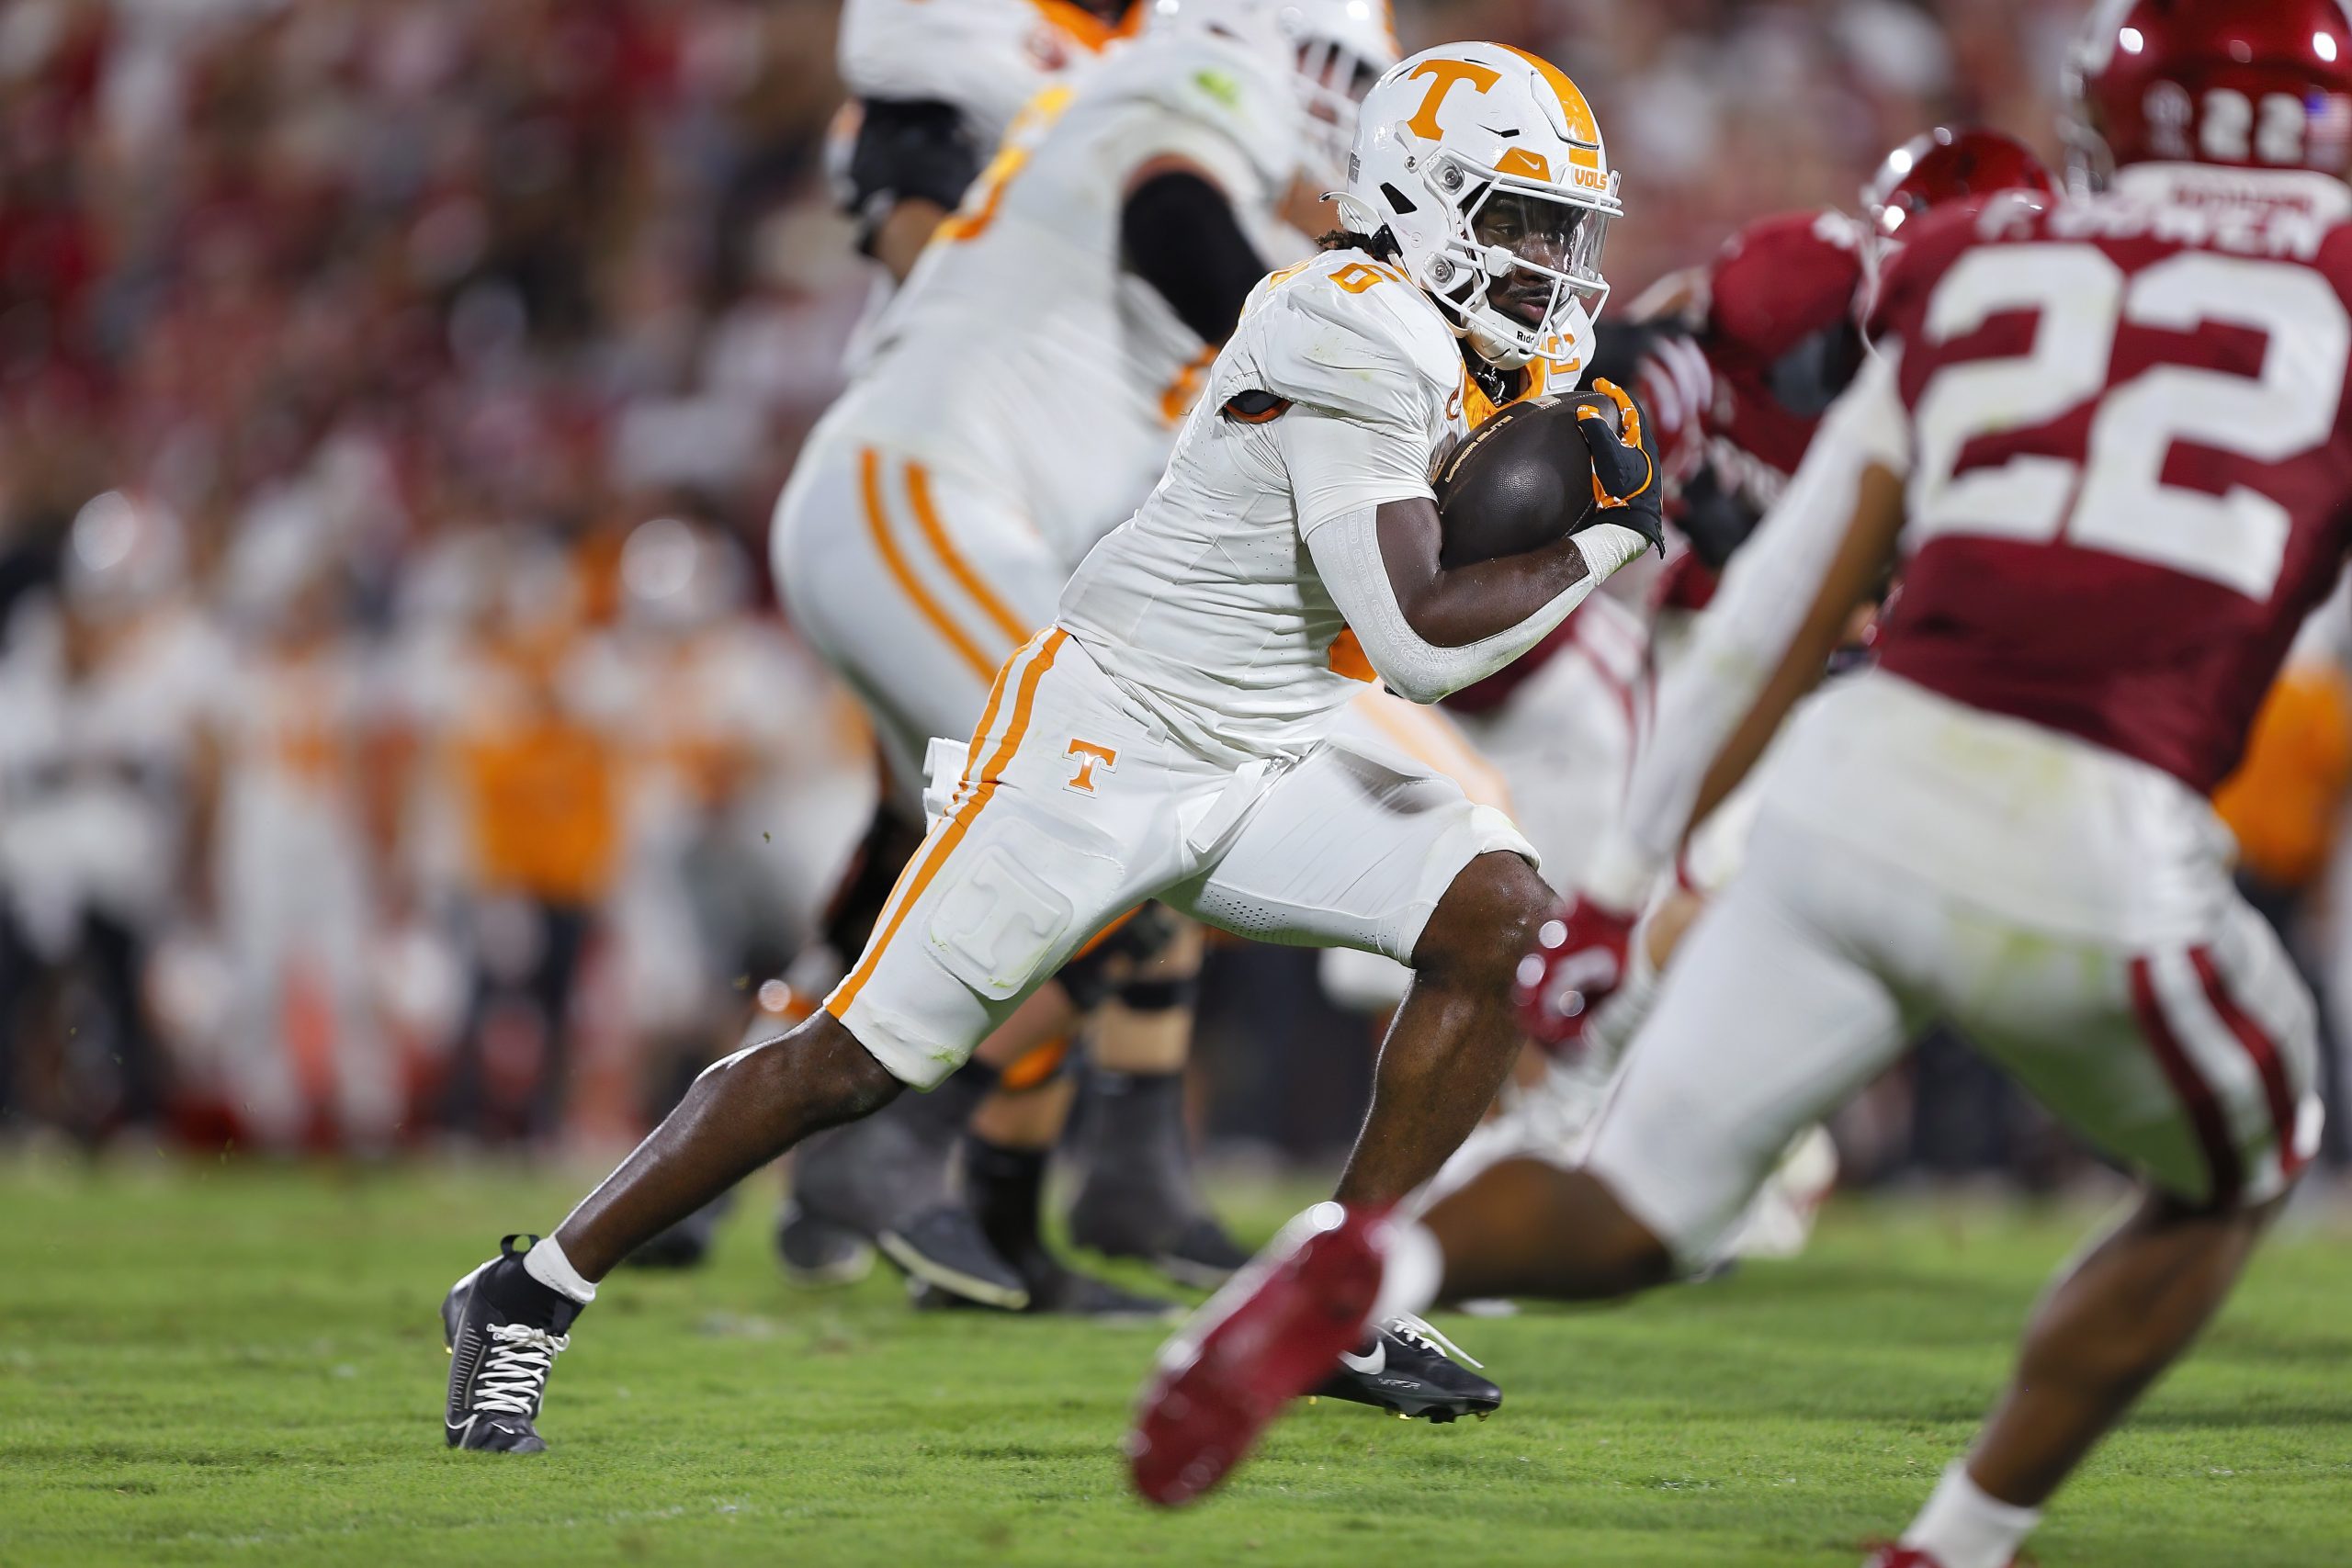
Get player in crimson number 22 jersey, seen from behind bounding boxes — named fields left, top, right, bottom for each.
left=1138, top=0, right=2352, bottom=1568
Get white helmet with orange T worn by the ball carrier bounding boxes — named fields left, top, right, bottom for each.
left=1339, top=42, right=1625, bottom=374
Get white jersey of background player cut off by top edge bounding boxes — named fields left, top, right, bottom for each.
left=837, top=0, right=1114, bottom=143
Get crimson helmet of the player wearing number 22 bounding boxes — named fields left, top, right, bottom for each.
left=2065, top=0, right=2352, bottom=188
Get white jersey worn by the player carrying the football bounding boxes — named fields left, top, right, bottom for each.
left=1058, top=252, right=1484, bottom=761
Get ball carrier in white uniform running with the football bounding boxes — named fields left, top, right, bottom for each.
left=445, top=42, right=1663, bottom=1450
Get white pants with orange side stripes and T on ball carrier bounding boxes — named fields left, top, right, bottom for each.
left=826, top=627, right=1536, bottom=1089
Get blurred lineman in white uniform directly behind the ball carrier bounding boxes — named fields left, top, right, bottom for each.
left=774, top=0, right=1395, bottom=1314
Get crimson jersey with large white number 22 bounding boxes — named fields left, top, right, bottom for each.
left=1872, top=164, right=2352, bottom=792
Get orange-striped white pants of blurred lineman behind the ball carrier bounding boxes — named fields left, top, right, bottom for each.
left=769, top=423, right=1068, bottom=813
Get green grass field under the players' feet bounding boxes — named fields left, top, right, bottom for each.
left=0, top=1164, right=2352, bottom=1568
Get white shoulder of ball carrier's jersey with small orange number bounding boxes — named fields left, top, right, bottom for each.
left=1226, top=252, right=1461, bottom=425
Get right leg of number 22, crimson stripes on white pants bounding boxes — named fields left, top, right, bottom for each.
left=1903, top=888, right=2319, bottom=1568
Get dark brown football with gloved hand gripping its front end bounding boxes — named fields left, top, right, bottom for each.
left=1435, top=381, right=1665, bottom=567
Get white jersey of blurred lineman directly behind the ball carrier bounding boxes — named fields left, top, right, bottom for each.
left=826, top=35, right=1301, bottom=564
